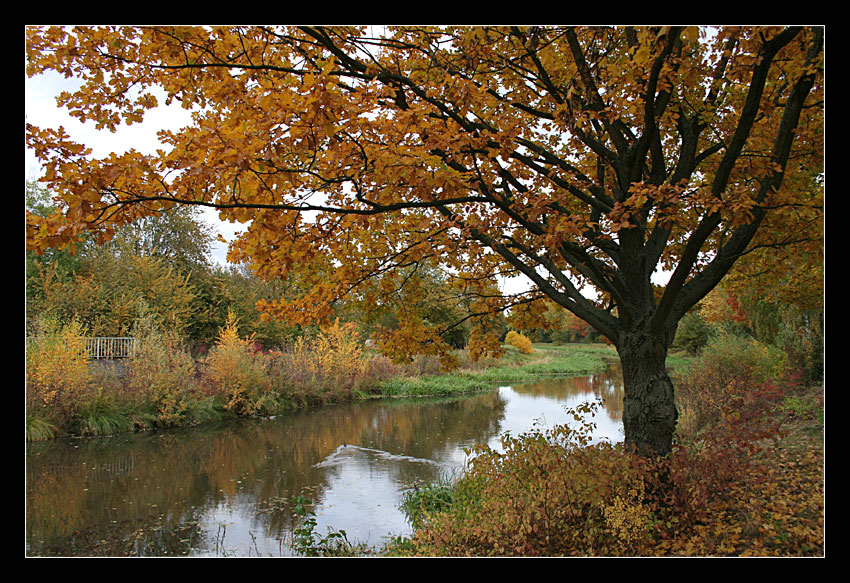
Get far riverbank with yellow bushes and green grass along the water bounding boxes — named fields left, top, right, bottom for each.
left=26, top=321, right=616, bottom=440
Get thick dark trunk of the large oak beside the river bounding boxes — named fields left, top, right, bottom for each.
left=617, top=332, right=678, bottom=457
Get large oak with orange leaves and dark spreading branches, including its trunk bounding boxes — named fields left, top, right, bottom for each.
left=26, top=26, right=824, bottom=454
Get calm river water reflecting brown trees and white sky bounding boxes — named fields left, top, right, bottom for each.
left=26, top=365, right=622, bottom=557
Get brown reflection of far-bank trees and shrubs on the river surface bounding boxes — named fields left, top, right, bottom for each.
left=26, top=392, right=504, bottom=556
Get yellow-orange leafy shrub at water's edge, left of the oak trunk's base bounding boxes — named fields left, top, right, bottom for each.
left=411, top=404, right=654, bottom=556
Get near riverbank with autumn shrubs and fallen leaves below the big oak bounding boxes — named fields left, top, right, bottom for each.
left=386, top=339, right=825, bottom=557
